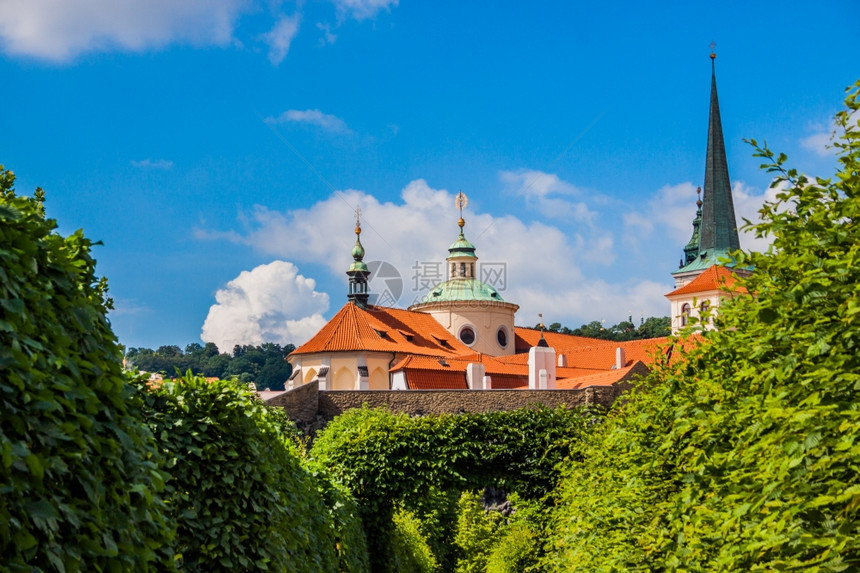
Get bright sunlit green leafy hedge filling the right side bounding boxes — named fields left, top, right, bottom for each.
left=554, top=82, right=860, bottom=571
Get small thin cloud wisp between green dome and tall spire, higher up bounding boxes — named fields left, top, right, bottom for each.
left=499, top=169, right=595, bottom=224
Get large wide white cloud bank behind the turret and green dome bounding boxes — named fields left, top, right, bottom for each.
left=197, top=179, right=664, bottom=326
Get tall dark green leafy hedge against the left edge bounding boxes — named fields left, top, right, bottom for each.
left=0, top=166, right=172, bottom=571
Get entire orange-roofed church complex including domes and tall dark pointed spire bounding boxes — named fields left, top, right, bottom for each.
left=287, top=53, right=746, bottom=390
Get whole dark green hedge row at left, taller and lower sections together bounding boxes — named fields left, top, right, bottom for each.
left=0, top=166, right=368, bottom=573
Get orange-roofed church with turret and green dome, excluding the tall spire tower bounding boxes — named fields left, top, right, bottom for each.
left=287, top=208, right=664, bottom=390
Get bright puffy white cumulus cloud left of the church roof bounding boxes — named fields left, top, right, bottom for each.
left=200, top=261, right=329, bottom=352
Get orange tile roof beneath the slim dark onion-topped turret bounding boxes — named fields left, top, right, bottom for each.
left=292, top=302, right=470, bottom=356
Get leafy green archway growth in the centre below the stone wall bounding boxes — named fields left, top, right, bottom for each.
left=310, top=408, right=592, bottom=571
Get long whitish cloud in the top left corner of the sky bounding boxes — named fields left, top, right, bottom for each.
left=0, top=0, right=247, bottom=61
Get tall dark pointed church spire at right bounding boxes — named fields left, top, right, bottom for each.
left=699, top=52, right=740, bottom=255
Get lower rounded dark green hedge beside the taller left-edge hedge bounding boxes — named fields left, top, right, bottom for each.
left=139, top=373, right=338, bottom=573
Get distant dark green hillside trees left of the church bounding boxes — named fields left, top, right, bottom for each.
left=125, top=342, right=296, bottom=390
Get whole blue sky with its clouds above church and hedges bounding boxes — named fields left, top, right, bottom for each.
left=0, top=0, right=860, bottom=350
